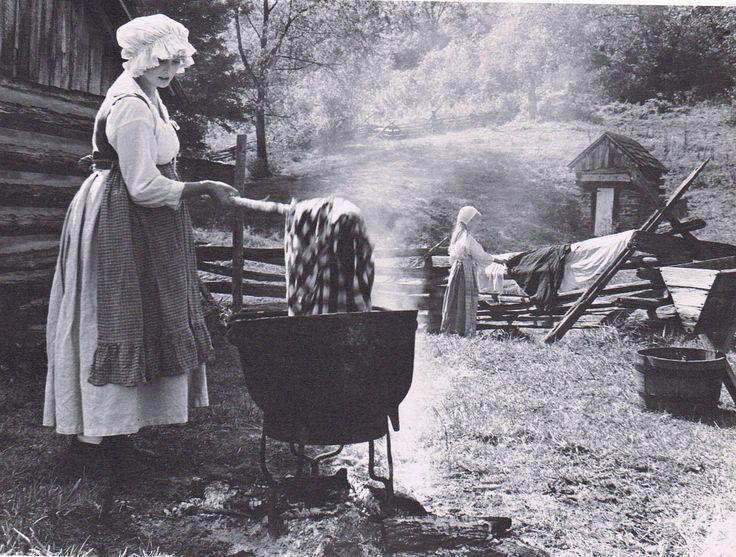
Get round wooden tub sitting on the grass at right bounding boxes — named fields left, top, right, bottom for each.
left=634, top=347, right=727, bottom=417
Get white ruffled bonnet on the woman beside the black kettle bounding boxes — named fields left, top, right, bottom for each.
left=116, top=14, right=196, bottom=77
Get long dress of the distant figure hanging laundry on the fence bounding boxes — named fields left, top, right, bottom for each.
left=440, top=232, right=493, bottom=336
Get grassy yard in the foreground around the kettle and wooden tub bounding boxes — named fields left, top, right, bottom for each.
left=0, top=328, right=736, bottom=557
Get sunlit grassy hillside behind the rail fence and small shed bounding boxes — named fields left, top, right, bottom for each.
left=230, top=104, right=736, bottom=252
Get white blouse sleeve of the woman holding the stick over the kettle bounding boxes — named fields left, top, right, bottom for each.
left=106, top=97, right=184, bottom=209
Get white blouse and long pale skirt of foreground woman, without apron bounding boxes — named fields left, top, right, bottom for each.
left=43, top=72, right=209, bottom=436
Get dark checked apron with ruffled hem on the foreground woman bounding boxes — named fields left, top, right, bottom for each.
left=89, top=163, right=212, bottom=386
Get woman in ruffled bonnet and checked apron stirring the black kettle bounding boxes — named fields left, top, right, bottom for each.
left=43, top=14, right=237, bottom=464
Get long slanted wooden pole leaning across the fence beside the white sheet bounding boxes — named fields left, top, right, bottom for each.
left=544, top=159, right=710, bottom=343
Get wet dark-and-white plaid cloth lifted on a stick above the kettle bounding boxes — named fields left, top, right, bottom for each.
left=284, top=198, right=374, bottom=315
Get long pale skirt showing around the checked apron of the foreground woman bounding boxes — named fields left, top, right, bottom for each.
left=43, top=171, right=208, bottom=436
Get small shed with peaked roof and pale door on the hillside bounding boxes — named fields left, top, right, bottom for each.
left=568, top=132, right=667, bottom=236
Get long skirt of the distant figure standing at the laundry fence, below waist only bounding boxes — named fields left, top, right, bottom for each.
left=440, top=261, right=478, bottom=336
